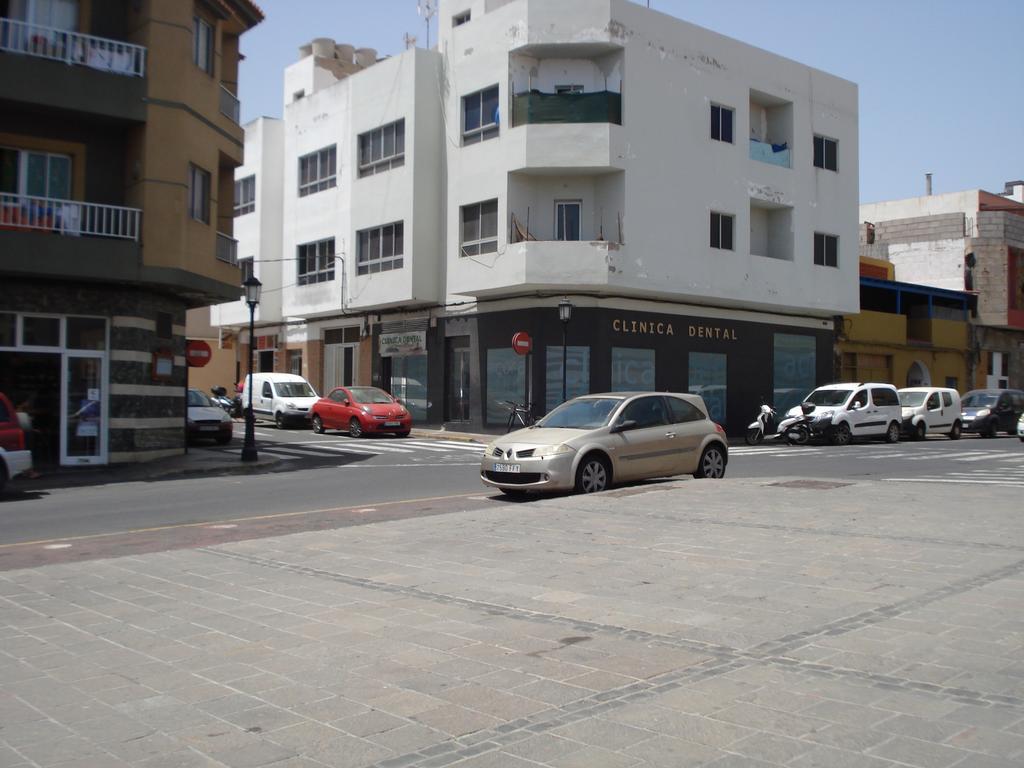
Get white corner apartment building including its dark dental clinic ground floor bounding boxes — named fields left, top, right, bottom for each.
left=214, top=0, right=858, bottom=432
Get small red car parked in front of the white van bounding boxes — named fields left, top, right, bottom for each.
left=311, top=387, right=413, bottom=437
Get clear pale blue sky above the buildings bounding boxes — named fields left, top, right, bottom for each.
left=239, top=0, right=1024, bottom=203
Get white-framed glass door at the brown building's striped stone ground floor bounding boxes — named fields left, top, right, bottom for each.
left=60, top=352, right=106, bottom=464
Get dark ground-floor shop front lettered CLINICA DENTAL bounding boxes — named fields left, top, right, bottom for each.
left=419, top=305, right=834, bottom=435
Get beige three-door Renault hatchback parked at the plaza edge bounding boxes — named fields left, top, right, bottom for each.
left=480, top=392, right=729, bottom=496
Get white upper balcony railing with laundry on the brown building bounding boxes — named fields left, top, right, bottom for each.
left=0, top=18, right=145, bottom=78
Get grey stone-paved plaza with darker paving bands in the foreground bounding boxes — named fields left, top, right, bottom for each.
left=0, top=478, right=1024, bottom=768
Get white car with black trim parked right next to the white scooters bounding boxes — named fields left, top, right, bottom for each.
left=787, top=382, right=903, bottom=445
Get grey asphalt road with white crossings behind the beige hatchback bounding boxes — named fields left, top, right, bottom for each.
left=0, top=428, right=1024, bottom=568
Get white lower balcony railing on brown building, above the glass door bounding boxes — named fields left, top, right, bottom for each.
left=0, top=193, right=142, bottom=241
